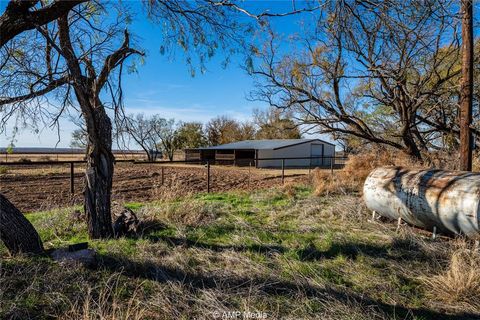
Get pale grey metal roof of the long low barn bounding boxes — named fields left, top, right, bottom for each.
left=193, top=139, right=333, bottom=150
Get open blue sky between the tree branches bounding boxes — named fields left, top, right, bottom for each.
left=0, top=0, right=318, bottom=147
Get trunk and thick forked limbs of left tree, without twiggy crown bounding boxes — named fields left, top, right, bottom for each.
left=58, top=16, right=142, bottom=239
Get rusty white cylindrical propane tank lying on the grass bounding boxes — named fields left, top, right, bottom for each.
left=363, top=167, right=480, bottom=237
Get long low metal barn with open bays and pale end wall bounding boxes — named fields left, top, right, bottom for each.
left=185, top=139, right=335, bottom=168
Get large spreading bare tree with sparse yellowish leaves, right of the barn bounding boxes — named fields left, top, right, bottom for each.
left=249, top=0, right=459, bottom=159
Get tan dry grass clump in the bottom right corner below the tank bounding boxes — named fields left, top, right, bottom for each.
left=422, top=241, right=480, bottom=312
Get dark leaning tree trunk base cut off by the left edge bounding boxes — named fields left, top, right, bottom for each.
left=0, top=193, right=43, bottom=255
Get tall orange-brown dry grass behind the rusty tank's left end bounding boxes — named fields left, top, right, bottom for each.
left=313, top=150, right=420, bottom=195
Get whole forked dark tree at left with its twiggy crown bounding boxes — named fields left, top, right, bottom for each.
left=0, top=2, right=142, bottom=238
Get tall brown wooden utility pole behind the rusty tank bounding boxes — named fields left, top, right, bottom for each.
left=460, top=0, right=473, bottom=171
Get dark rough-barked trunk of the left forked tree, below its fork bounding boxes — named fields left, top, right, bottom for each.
left=84, top=107, right=114, bottom=239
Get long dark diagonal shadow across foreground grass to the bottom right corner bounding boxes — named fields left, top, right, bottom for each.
left=97, top=255, right=479, bottom=320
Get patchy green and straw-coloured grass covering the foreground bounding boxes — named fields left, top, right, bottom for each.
left=0, top=186, right=472, bottom=319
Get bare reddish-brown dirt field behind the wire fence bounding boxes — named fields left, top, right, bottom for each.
left=0, top=163, right=308, bottom=212
